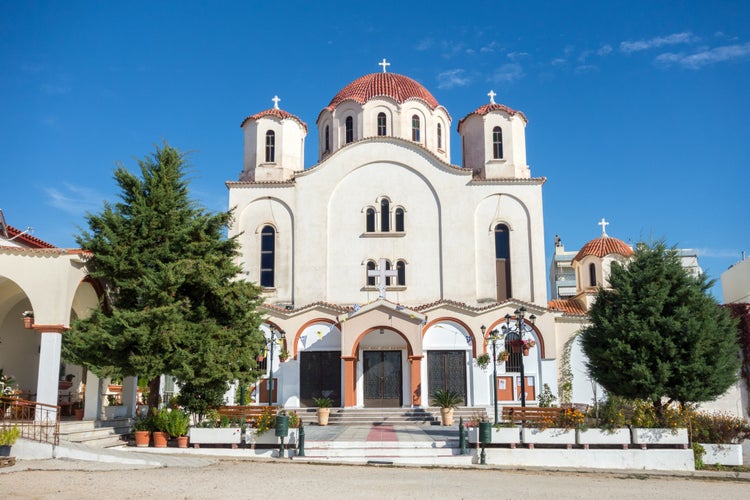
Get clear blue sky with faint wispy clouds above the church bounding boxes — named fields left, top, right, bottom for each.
left=0, top=0, right=750, bottom=298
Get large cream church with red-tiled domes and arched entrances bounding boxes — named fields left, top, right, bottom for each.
left=227, top=60, right=588, bottom=407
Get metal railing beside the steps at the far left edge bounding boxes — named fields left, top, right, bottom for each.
left=0, top=397, right=60, bottom=445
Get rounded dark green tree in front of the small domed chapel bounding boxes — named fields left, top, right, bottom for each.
left=581, top=241, right=740, bottom=414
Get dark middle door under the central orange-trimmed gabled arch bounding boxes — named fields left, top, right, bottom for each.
left=362, top=351, right=403, bottom=408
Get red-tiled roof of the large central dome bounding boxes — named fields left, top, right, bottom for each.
left=328, top=73, right=438, bottom=111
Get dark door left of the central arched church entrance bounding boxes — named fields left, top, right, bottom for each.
left=299, top=351, right=341, bottom=407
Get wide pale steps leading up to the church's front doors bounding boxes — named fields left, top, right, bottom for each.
left=296, top=407, right=487, bottom=425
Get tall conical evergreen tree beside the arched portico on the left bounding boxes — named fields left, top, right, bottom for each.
left=63, top=144, right=264, bottom=407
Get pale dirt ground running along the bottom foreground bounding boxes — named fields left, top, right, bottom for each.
left=0, top=460, right=750, bottom=500
